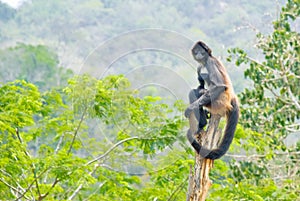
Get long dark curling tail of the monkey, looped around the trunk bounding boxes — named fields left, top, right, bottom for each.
left=187, top=99, right=239, bottom=160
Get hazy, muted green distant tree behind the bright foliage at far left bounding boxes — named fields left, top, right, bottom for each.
left=0, top=43, right=72, bottom=91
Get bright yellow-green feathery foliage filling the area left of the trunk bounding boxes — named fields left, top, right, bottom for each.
left=0, top=75, right=189, bottom=200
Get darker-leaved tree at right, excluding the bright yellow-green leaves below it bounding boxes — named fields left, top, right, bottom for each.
left=229, top=1, right=300, bottom=150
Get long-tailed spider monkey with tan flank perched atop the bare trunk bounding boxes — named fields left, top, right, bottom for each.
left=185, top=41, right=239, bottom=160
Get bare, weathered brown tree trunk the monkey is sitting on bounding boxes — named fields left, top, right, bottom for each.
left=187, top=113, right=222, bottom=201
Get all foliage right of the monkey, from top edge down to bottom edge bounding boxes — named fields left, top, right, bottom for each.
left=223, top=0, right=300, bottom=200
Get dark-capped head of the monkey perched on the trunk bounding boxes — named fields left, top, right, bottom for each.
left=192, top=41, right=212, bottom=63
